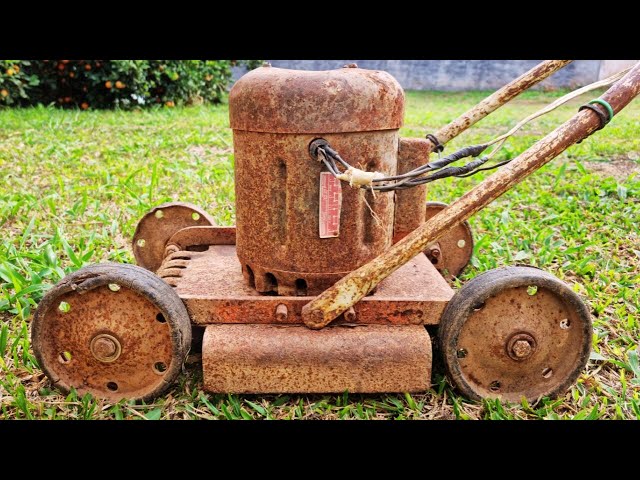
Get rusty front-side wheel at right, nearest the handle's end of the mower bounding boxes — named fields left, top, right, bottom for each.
left=439, top=267, right=592, bottom=402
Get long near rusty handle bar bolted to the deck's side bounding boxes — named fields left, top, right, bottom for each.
left=302, top=63, right=640, bottom=329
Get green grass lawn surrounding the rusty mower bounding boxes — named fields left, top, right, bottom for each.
left=0, top=88, right=640, bottom=419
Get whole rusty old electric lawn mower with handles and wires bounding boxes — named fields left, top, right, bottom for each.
left=32, top=60, right=640, bottom=402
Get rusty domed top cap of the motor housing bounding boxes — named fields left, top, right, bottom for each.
left=229, top=67, right=404, bottom=134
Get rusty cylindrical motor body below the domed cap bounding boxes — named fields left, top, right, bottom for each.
left=234, top=130, right=398, bottom=295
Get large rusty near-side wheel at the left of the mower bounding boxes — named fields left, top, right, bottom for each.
left=31, top=263, right=191, bottom=401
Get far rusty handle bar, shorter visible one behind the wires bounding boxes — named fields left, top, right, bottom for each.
left=430, top=60, right=573, bottom=147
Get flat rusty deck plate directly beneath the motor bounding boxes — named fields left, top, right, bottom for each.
left=166, top=245, right=454, bottom=325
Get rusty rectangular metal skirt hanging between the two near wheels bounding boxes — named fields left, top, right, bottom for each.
left=202, top=325, right=431, bottom=393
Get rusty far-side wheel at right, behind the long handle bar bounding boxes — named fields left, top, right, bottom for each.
left=424, top=202, right=473, bottom=280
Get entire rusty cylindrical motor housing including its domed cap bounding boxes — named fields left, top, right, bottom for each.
left=229, top=66, right=424, bottom=295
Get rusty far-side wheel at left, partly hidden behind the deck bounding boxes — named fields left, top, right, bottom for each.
left=133, top=202, right=215, bottom=272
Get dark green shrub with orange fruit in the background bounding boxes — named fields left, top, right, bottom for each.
left=0, top=60, right=260, bottom=109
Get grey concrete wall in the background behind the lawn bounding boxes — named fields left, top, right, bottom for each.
left=234, top=60, right=602, bottom=90
